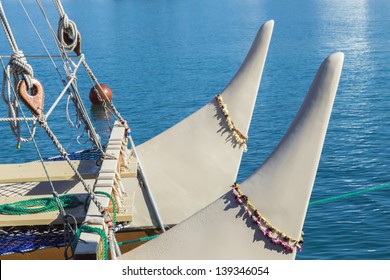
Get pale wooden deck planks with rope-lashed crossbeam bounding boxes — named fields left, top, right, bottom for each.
left=0, top=123, right=140, bottom=258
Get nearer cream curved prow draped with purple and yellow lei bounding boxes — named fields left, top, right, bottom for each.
left=122, top=53, right=344, bottom=259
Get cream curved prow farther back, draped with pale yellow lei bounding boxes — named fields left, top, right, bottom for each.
left=130, top=20, right=274, bottom=228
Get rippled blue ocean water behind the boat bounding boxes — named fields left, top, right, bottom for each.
left=0, top=0, right=390, bottom=259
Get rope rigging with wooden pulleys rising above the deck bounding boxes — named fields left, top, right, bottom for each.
left=0, top=0, right=153, bottom=258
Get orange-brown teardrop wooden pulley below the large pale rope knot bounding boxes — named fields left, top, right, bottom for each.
left=18, top=78, right=45, bottom=116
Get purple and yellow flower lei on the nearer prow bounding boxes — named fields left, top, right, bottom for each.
left=231, top=183, right=303, bottom=253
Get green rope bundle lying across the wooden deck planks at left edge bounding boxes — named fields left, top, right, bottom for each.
left=0, top=194, right=81, bottom=215
